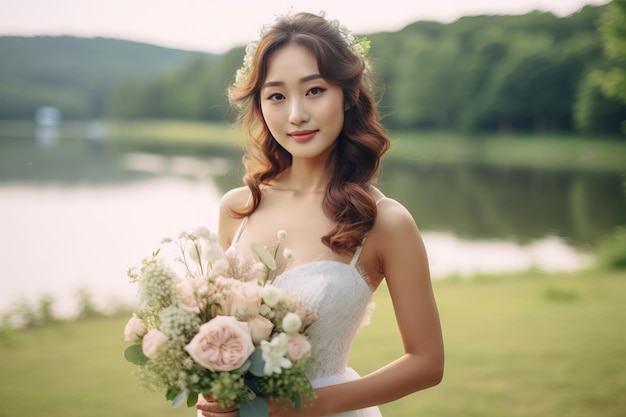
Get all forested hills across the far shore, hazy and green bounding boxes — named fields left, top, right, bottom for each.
left=0, top=0, right=626, bottom=135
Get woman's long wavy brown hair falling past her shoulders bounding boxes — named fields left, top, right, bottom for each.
left=228, top=13, right=389, bottom=253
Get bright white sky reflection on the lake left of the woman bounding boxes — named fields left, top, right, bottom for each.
left=0, top=177, right=220, bottom=315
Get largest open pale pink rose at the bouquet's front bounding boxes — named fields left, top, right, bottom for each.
left=185, top=316, right=254, bottom=372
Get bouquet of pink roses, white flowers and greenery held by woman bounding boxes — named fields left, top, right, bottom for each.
left=124, top=228, right=316, bottom=417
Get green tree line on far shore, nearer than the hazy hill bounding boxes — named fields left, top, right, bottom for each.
left=108, top=6, right=626, bottom=135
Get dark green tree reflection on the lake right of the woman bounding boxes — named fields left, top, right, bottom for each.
left=382, top=161, right=626, bottom=249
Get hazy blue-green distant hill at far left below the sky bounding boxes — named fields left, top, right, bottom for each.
left=0, top=36, right=214, bottom=119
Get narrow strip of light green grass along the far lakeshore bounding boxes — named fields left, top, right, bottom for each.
left=106, top=120, right=626, bottom=172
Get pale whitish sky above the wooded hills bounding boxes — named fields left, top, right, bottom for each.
left=0, top=0, right=608, bottom=54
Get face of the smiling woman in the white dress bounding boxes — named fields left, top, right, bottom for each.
left=260, top=44, right=345, bottom=161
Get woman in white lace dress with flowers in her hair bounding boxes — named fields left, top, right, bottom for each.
left=197, top=9, right=443, bottom=417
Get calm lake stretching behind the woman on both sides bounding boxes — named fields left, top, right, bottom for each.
left=0, top=120, right=626, bottom=316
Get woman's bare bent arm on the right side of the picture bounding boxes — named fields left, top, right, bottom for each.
left=270, top=199, right=444, bottom=417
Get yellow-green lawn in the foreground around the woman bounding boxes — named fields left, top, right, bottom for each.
left=0, top=272, right=626, bottom=417
